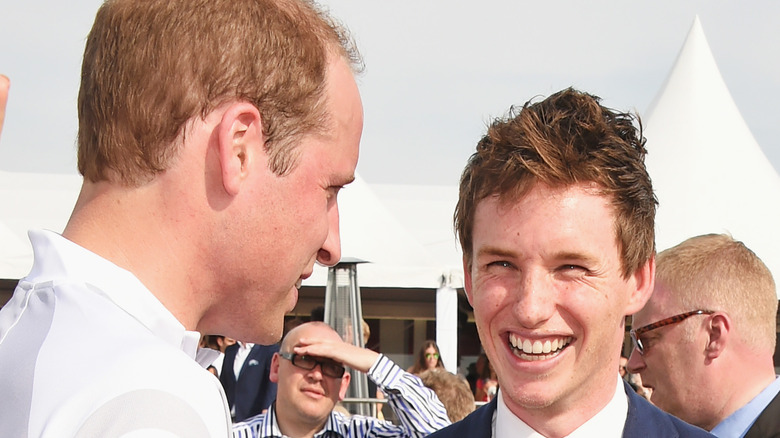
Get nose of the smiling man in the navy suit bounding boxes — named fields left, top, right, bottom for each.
left=510, top=272, right=555, bottom=328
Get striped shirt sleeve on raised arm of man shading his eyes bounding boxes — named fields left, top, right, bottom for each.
left=368, top=354, right=450, bottom=437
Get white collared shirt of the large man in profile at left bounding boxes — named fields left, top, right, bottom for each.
left=0, top=231, right=230, bottom=437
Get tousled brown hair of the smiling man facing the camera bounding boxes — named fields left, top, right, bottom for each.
left=454, top=88, right=657, bottom=277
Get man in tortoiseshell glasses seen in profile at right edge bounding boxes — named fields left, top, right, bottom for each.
left=628, top=234, right=780, bottom=438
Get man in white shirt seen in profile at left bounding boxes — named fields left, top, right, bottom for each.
left=0, top=0, right=363, bottom=437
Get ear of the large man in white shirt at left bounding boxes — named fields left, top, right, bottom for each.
left=216, top=102, right=265, bottom=196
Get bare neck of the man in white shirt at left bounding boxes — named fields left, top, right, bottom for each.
left=62, top=181, right=210, bottom=330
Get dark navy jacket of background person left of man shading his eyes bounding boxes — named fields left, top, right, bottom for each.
left=219, top=344, right=279, bottom=422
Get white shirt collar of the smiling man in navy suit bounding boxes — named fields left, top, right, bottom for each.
left=493, top=376, right=628, bottom=438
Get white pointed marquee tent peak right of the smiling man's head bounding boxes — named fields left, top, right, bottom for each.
left=645, top=17, right=780, bottom=294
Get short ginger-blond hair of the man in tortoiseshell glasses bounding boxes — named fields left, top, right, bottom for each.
left=655, top=234, right=777, bottom=353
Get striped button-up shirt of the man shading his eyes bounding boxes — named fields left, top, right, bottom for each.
left=233, top=354, right=450, bottom=438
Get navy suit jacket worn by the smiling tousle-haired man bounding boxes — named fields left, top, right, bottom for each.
left=429, top=384, right=713, bottom=438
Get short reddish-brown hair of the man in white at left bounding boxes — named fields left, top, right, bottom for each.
left=78, top=0, right=362, bottom=185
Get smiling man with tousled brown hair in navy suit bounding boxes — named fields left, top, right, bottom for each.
left=436, top=89, right=707, bottom=438
